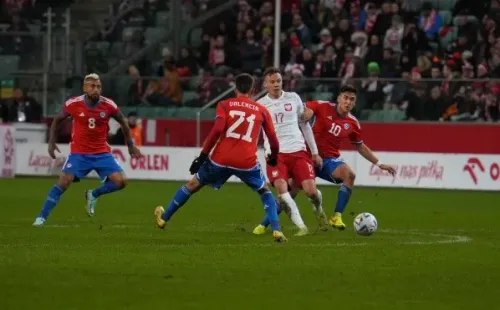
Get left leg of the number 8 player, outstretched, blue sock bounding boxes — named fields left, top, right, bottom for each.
left=33, top=154, right=91, bottom=226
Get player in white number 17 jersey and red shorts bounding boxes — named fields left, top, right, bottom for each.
left=254, top=67, right=328, bottom=236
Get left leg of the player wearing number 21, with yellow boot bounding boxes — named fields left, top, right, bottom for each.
left=155, top=160, right=226, bottom=229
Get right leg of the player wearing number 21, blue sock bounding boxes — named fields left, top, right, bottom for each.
left=233, top=165, right=286, bottom=242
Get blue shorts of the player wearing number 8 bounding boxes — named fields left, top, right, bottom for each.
left=62, top=153, right=123, bottom=182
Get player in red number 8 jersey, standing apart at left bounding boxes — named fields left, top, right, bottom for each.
left=33, top=73, right=141, bottom=226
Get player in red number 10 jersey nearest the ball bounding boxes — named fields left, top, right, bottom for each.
left=305, top=86, right=396, bottom=230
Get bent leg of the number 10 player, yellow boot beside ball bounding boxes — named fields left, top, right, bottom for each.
left=322, top=158, right=356, bottom=230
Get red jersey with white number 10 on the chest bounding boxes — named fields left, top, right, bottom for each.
left=306, top=100, right=363, bottom=157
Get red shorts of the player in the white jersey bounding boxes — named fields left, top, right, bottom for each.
left=266, top=151, right=316, bottom=186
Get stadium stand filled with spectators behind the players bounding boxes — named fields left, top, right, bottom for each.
left=0, top=0, right=500, bottom=121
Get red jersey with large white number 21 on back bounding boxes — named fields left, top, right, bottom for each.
left=210, top=96, right=276, bottom=169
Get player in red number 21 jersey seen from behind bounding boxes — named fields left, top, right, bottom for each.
left=154, top=74, right=286, bottom=242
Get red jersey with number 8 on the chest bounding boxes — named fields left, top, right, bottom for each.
left=63, top=95, right=119, bottom=154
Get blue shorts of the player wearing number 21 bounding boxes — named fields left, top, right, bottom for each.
left=196, top=160, right=266, bottom=191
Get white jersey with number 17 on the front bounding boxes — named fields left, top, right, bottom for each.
left=258, top=92, right=307, bottom=154
